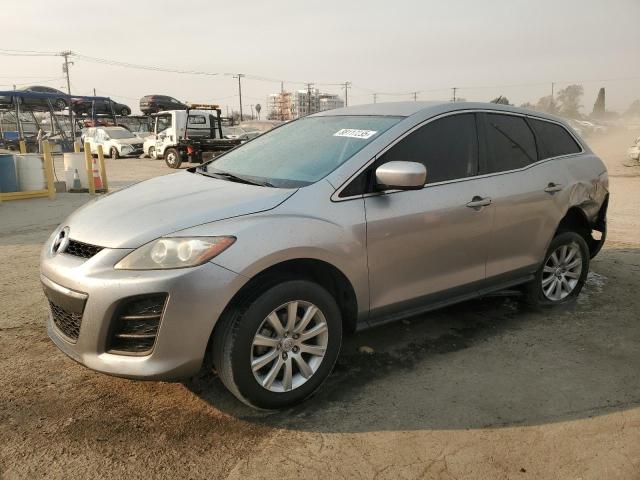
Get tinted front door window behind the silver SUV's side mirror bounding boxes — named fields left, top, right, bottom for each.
left=376, top=113, right=478, bottom=184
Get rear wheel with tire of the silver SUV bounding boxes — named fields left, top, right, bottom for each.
left=525, top=232, right=590, bottom=307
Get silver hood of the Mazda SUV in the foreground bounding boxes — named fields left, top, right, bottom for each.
left=65, top=171, right=296, bottom=248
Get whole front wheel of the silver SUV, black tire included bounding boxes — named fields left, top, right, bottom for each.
left=212, top=280, right=342, bottom=410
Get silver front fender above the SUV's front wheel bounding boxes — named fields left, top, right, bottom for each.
left=174, top=189, right=369, bottom=316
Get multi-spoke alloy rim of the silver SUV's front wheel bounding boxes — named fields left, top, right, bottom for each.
left=251, top=300, right=329, bottom=392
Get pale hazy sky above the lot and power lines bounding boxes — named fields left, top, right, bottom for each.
left=0, top=0, right=640, bottom=113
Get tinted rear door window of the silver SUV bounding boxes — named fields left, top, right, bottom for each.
left=482, top=113, right=538, bottom=173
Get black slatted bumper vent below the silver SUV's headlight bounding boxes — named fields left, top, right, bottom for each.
left=107, top=293, right=167, bottom=355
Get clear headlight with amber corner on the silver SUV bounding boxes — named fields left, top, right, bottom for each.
left=114, top=237, right=236, bottom=270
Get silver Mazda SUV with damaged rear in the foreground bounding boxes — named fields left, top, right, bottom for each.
left=41, top=102, right=608, bottom=408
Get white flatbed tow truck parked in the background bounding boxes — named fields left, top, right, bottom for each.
left=143, top=105, right=241, bottom=168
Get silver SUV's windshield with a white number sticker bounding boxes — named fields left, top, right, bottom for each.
left=202, top=116, right=402, bottom=188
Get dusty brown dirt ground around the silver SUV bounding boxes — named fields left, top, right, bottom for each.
left=0, top=128, right=640, bottom=479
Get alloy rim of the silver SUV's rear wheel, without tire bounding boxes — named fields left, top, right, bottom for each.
left=542, top=243, right=582, bottom=302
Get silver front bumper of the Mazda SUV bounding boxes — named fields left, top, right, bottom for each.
left=41, top=241, right=245, bottom=380
